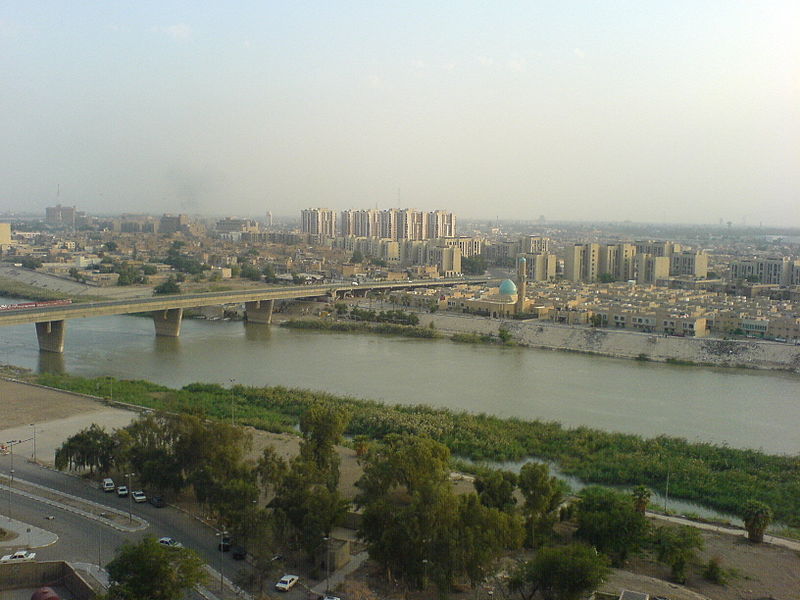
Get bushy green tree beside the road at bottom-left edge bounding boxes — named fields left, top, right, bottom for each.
left=106, top=536, right=206, bottom=600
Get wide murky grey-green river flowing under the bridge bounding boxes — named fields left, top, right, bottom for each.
left=0, top=298, right=800, bottom=454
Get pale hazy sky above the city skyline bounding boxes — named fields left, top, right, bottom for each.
left=0, top=0, right=800, bottom=226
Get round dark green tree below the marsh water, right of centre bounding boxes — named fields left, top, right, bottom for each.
left=575, top=486, right=648, bottom=564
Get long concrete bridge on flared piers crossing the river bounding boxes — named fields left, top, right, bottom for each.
left=0, top=277, right=488, bottom=352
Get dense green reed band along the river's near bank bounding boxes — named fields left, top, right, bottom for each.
left=31, top=372, right=800, bottom=526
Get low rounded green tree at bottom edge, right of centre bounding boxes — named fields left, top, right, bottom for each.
left=508, top=544, right=610, bottom=600
